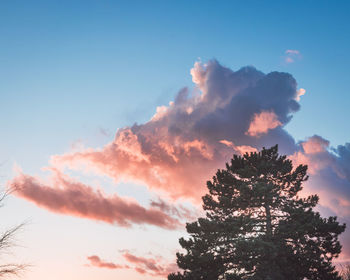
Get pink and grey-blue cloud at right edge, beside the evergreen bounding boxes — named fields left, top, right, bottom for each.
left=290, top=135, right=350, bottom=259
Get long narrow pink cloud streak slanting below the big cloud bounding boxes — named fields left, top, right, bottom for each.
left=11, top=167, right=180, bottom=229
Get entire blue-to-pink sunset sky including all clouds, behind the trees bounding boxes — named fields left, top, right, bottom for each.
left=0, top=0, right=350, bottom=280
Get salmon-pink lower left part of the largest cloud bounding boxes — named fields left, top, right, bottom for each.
left=51, top=129, right=220, bottom=200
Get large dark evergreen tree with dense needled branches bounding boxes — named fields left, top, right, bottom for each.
left=168, top=145, right=345, bottom=280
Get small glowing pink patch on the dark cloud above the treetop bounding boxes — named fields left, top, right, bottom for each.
left=246, top=111, right=282, bottom=137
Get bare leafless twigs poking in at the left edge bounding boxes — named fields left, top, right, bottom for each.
left=0, top=190, right=26, bottom=279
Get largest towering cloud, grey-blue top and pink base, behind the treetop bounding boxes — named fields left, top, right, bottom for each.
left=47, top=60, right=299, bottom=202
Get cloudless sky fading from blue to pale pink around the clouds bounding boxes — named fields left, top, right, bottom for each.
left=0, top=0, right=350, bottom=280
